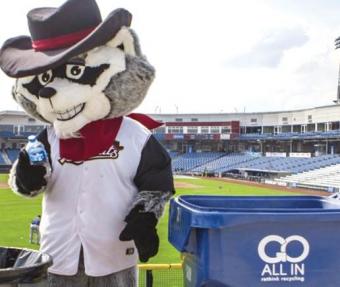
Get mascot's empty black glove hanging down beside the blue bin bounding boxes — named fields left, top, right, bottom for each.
left=119, top=205, right=159, bottom=262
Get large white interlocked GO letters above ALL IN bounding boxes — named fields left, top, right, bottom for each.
left=257, top=235, right=309, bottom=264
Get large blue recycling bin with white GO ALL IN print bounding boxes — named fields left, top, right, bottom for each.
left=169, top=195, right=340, bottom=287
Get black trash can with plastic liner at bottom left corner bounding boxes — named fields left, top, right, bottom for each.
left=0, top=247, right=52, bottom=284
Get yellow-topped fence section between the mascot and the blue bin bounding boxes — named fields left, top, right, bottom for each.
left=138, top=263, right=183, bottom=287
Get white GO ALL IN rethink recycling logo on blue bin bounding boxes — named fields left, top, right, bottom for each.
left=257, top=235, right=310, bottom=282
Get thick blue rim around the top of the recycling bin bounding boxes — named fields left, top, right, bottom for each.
left=168, top=195, right=340, bottom=252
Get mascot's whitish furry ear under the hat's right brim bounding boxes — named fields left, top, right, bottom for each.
left=106, top=27, right=138, bottom=56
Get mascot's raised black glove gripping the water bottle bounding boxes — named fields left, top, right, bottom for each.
left=16, top=149, right=47, bottom=195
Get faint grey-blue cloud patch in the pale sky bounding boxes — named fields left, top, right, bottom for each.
left=226, top=28, right=309, bottom=68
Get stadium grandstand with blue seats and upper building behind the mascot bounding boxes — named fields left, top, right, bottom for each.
left=0, top=103, right=340, bottom=190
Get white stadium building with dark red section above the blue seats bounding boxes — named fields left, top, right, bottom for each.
left=152, top=105, right=340, bottom=156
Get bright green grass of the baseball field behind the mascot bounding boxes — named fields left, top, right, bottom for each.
left=0, top=175, right=298, bottom=263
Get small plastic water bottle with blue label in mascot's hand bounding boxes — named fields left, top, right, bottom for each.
left=25, top=135, right=51, bottom=176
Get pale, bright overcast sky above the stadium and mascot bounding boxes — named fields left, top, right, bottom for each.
left=0, top=0, right=340, bottom=113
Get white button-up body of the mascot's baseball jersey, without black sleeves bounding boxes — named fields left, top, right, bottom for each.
left=40, top=117, right=150, bottom=276
